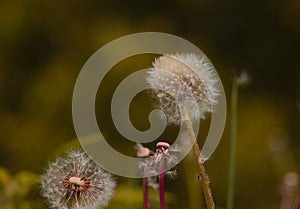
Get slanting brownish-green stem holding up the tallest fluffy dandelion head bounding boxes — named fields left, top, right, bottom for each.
left=182, top=106, right=215, bottom=209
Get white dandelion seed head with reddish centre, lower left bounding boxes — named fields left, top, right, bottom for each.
left=41, top=150, right=116, bottom=209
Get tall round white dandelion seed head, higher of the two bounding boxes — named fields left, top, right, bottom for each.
left=147, top=53, right=219, bottom=124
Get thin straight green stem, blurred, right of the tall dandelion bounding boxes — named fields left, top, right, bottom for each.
left=227, top=78, right=239, bottom=209
